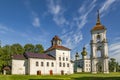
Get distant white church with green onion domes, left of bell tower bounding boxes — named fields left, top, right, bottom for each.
left=74, top=47, right=91, bottom=72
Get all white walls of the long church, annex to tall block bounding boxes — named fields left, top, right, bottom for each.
left=12, top=50, right=73, bottom=75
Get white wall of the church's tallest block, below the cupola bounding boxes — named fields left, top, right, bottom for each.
left=56, top=50, right=73, bottom=74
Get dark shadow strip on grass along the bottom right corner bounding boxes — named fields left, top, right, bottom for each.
left=71, top=77, right=120, bottom=80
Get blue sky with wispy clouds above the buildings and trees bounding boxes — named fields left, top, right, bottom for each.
left=0, top=0, right=120, bottom=62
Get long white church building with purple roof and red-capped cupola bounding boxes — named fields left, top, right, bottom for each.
left=12, top=36, right=73, bottom=75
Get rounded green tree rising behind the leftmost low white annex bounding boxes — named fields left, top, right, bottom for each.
left=11, top=43, right=24, bottom=54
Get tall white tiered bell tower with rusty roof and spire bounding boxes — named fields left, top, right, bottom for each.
left=90, top=11, right=109, bottom=73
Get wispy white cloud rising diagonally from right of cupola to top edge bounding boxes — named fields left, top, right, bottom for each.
left=62, top=0, right=96, bottom=49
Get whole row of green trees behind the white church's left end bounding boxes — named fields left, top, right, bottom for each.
left=0, top=43, right=44, bottom=73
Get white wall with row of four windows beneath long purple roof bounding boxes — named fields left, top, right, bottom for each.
left=29, top=58, right=56, bottom=75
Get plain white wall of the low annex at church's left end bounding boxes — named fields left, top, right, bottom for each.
left=12, top=59, right=26, bottom=74
